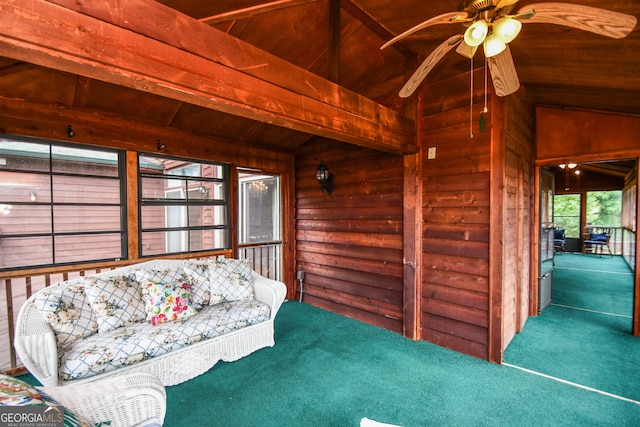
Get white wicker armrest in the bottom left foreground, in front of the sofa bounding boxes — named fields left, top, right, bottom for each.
left=39, top=372, right=167, bottom=427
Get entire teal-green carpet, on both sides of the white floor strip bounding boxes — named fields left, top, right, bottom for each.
left=16, top=254, right=640, bottom=427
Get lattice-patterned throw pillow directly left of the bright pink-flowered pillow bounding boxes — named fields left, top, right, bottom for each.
left=84, top=276, right=146, bottom=332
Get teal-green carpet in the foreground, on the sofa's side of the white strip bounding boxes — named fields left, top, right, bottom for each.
left=165, top=302, right=640, bottom=427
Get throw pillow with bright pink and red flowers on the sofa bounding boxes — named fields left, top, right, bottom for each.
left=143, top=282, right=197, bottom=325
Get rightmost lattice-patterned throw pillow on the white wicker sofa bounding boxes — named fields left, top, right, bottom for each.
left=211, top=258, right=254, bottom=304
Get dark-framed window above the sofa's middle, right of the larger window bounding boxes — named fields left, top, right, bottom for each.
left=138, top=155, right=230, bottom=256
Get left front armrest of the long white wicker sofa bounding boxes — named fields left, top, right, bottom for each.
left=14, top=300, right=58, bottom=387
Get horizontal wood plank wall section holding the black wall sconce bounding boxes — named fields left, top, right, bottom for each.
left=295, top=140, right=403, bottom=333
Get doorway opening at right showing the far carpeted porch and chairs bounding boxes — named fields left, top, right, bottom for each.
left=538, top=160, right=639, bottom=331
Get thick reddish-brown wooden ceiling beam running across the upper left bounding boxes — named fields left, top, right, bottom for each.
left=0, top=0, right=418, bottom=154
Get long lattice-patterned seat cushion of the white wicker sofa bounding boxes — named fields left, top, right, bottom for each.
left=59, top=300, right=271, bottom=381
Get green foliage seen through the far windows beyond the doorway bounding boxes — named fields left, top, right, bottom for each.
left=553, top=191, right=622, bottom=238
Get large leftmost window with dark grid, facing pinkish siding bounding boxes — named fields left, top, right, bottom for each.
left=0, top=138, right=127, bottom=269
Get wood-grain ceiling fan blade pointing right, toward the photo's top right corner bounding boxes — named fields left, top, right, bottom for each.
left=518, top=3, right=637, bottom=39
